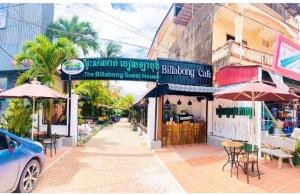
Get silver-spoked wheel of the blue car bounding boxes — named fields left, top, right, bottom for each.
left=17, top=160, right=41, bottom=193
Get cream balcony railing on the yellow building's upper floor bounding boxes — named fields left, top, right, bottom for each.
left=212, top=40, right=273, bottom=69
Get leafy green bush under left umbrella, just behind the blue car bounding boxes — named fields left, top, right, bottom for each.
left=1, top=99, right=32, bottom=136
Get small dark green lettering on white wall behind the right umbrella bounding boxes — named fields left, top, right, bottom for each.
left=216, top=106, right=252, bottom=118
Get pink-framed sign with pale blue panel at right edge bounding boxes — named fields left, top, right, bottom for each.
left=273, top=35, right=300, bottom=81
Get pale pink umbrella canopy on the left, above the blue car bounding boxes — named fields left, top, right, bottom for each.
left=0, top=81, right=66, bottom=99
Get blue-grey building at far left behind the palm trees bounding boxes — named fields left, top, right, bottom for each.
left=0, top=3, right=54, bottom=114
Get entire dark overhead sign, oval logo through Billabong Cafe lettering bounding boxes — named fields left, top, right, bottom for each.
left=61, top=58, right=213, bottom=86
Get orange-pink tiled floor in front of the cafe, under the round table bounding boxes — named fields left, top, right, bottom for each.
left=156, top=145, right=300, bottom=193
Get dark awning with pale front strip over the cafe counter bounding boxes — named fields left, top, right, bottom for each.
left=144, top=84, right=220, bottom=100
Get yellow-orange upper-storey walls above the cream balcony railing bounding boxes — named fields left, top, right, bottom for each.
left=213, top=5, right=295, bottom=54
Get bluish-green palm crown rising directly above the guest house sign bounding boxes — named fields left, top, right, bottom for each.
left=46, top=16, right=99, bottom=55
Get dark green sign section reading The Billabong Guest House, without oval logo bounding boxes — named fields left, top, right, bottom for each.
left=61, top=58, right=159, bottom=82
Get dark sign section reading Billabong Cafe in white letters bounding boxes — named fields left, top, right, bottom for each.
left=157, top=59, right=213, bottom=87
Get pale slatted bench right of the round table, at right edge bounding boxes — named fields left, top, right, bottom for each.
left=261, top=135, right=296, bottom=169
